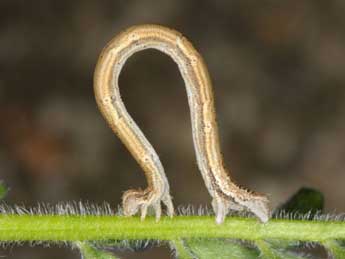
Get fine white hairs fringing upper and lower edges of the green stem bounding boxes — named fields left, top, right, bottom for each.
left=0, top=201, right=345, bottom=255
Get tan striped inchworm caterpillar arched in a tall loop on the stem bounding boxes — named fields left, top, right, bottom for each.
left=94, top=25, right=270, bottom=223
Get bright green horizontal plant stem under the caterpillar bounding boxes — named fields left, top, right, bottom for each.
left=0, top=215, right=345, bottom=242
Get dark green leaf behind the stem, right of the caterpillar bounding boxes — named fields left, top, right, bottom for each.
left=274, top=187, right=324, bottom=219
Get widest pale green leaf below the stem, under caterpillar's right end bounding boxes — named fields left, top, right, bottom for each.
left=185, top=239, right=259, bottom=259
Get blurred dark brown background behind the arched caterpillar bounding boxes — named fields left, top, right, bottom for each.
left=0, top=0, right=345, bottom=259
